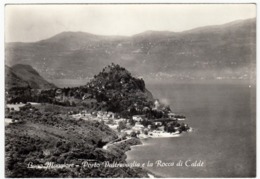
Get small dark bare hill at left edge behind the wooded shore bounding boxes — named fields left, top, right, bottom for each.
left=5, top=64, right=56, bottom=89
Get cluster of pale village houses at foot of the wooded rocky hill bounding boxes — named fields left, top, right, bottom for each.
left=68, top=110, right=191, bottom=138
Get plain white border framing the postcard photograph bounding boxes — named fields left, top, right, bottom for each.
left=0, top=0, right=260, bottom=178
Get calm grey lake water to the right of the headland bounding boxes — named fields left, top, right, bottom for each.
left=127, top=82, right=256, bottom=177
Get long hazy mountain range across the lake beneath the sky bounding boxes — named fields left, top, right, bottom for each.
left=5, top=18, right=256, bottom=86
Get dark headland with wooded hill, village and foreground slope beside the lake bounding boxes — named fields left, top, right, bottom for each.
left=5, top=64, right=190, bottom=177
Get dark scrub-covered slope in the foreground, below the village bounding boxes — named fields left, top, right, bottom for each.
left=5, top=103, right=144, bottom=177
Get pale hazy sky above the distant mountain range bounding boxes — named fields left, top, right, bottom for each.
left=5, top=4, right=256, bottom=42
